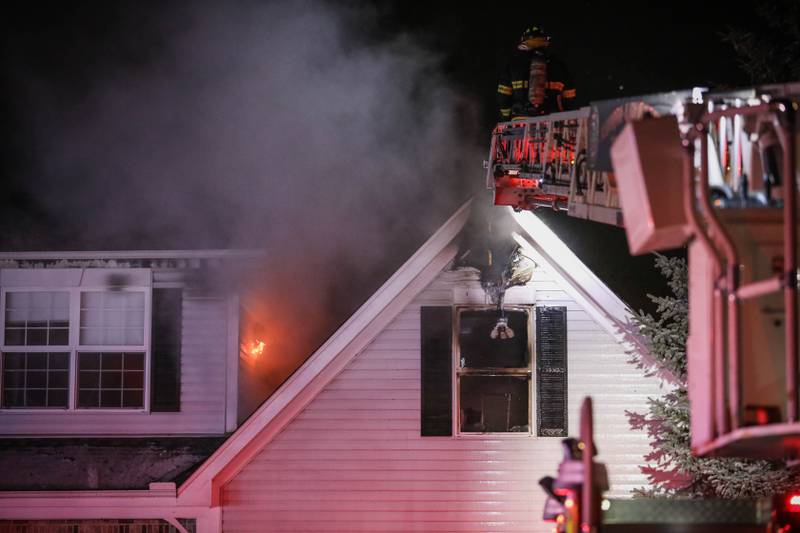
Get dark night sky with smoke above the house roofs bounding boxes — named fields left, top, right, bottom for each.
left=0, top=1, right=759, bottom=324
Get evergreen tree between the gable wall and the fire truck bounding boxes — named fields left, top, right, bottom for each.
left=629, top=255, right=798, bottom=499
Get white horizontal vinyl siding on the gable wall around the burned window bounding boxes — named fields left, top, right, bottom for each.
left=223, top=267, right=661, bottom=533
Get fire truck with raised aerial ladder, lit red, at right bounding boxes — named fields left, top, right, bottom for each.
left=485, top=83, right=800, bottom=532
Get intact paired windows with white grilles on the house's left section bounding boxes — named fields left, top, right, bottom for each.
left=0, top=287, right=151, bottom=410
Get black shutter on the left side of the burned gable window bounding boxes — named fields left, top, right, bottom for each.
left=420, top=307, right=453, bottom=437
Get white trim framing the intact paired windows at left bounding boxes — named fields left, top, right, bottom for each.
left=0, top=285, right=153, bottom=415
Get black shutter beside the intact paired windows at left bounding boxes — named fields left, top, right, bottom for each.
left=150, top=289, right=183, bottom=412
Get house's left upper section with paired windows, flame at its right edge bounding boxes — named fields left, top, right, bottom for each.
left=0, top=250, right=272, bottom=489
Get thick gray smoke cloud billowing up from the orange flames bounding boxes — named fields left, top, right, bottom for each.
left=14, top=2, right=484, bottom=394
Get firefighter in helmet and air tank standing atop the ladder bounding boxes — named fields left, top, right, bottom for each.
left=497, top=26, right=575, bottom=122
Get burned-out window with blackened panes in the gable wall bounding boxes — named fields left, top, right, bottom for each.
left=456, top=306, right=531, bottom=433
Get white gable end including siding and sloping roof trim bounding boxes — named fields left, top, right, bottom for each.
left=0, top=204, right=659, bottom=532
